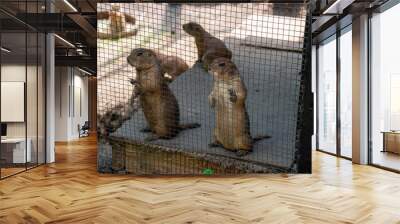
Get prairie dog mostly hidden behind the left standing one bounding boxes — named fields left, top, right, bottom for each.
left=156, top=52, right=189, bottom=82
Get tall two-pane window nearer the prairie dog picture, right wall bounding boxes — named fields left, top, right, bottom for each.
left=316, top=25, right=352, bottom=158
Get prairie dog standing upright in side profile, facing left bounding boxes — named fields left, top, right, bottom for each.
left=127, top=48, right=200, bottom=141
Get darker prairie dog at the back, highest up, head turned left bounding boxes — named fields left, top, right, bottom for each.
left=182, top=22, right=232, bottom=69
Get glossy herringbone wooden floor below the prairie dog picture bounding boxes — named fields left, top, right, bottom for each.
left=0, top=138, right=400, bottom=224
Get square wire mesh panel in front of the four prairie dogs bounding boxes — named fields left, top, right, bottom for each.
left=97, top=3, right=308, bottom=175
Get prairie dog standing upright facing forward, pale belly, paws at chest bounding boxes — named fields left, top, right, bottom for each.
left=208, top=58, right=269, bottom=156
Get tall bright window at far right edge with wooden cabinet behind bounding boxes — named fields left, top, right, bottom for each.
left=370, top=4, right=400, bottom=170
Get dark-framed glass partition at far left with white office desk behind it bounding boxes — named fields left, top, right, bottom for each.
left=0, top=1, right=46, bottom=178
